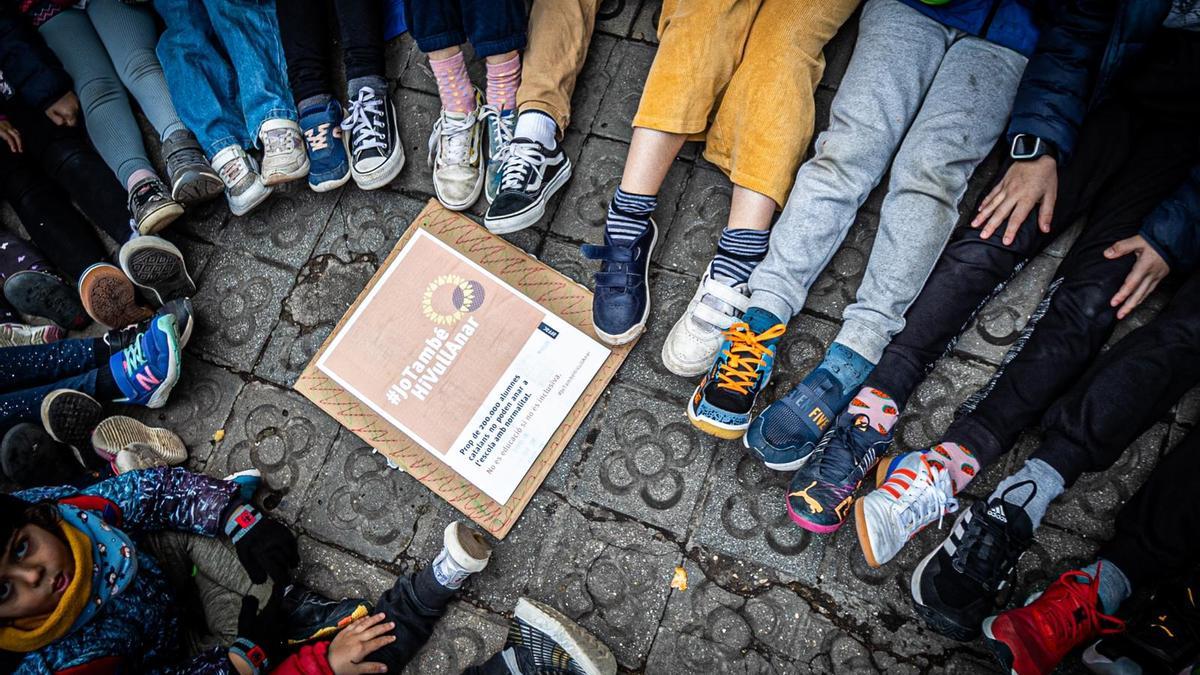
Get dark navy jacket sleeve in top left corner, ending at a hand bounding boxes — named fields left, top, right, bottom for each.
left=0, top=4, right=72, bottom=110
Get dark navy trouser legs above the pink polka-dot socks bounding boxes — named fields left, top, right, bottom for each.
left=404, top=0, right=528, bottom=59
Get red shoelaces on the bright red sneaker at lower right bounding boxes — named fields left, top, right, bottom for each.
left=1030, top=562, right=1124, bottom=645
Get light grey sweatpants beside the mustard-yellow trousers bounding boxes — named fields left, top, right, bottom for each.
left=750, top=0, right=1026, bottom=363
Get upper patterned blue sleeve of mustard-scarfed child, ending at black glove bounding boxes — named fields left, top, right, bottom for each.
left=79, top=467, right=238, bottom=537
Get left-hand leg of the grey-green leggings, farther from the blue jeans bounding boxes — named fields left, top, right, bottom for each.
left=40, top=10, right=155, bottom=190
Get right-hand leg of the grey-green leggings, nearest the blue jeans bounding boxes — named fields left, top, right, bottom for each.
left=88, top=0, right=187, bottom=141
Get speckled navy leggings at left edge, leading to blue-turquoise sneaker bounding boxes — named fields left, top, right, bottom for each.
left=0, top=339, right=108, bottom=434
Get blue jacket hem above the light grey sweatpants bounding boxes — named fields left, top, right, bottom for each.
left=900, top=0, right=1039, bottom=56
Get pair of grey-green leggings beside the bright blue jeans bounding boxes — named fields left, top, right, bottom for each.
left=40, top=0, right=186, bottom=187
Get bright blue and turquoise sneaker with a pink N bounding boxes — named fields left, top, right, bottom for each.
left=109, top=313, right=180, bottom=408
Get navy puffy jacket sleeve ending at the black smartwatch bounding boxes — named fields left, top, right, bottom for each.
left=1008, top=0, right=1120, bottom=160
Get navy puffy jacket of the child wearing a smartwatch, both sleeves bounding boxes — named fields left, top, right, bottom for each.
left=1008, top=0, right=1200, bottom=273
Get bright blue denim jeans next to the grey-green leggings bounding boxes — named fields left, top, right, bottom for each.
left=154, top=0, right=296, bottom=157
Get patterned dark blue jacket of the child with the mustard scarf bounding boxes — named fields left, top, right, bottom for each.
left=7, top=468, right=236, bottom=675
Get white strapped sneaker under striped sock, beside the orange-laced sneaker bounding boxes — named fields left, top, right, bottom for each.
left=662, top=271, right=750, bottom=377
